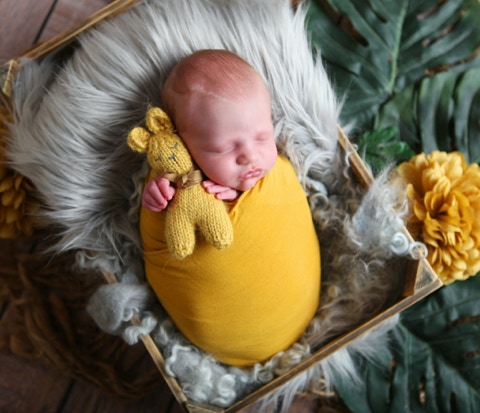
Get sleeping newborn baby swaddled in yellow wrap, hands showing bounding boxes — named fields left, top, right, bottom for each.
left=140, top=50, right=320, bottom=367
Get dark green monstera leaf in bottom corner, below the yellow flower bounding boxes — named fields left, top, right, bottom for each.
left=337, top=277, right=480, bottom=413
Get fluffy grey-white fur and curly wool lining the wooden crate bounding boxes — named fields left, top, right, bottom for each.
left=7, top=0, right=420, bottom=410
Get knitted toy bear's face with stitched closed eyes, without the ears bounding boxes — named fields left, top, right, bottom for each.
left=148, top=133, right=193, bottom=174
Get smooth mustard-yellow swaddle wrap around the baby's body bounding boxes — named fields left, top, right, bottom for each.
left=140, top=156, right=320, bottom=366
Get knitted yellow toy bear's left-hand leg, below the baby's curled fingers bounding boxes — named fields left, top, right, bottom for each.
left=165, top=208, right=195, bottom=259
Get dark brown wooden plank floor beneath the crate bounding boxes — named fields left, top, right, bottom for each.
left=0, top=0, right=345, bottom=413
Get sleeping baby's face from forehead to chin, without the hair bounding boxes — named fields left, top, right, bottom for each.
left=176, top=88, right=277, bottom=191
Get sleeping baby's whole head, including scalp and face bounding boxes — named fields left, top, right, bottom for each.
left=162, top=50, right=277, bottom=191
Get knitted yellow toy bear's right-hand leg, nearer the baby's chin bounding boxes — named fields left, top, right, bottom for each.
left=198, top=199, right=233, bottom=250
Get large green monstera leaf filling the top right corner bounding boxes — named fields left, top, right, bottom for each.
left=307, top=0, right=480, bottom=128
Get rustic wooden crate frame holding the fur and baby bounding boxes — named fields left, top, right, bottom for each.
left=0, top=0, right=442, bottom=413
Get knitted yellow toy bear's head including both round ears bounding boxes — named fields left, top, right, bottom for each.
left=128, top=108, right=193, bottom=175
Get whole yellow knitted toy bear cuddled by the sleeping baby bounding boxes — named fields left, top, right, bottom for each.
left=128, top=107, right=233, bottom=259
